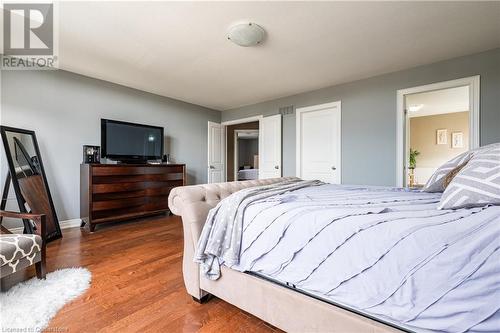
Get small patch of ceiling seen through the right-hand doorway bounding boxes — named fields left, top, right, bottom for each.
left=406, top=86, right=469, bottom=118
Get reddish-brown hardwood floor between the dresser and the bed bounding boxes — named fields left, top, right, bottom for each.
left=9, top=216, right=277, bottom=332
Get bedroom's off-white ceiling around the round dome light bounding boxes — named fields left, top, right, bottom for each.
left=53, top=1, right=500, bottom=110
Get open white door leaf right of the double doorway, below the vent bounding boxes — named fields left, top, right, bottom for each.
left=259, top=114, right=281, bottom=179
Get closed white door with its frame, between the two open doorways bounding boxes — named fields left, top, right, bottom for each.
left=296, top=102, right=341, bottom=184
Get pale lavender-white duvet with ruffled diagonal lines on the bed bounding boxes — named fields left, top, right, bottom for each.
left=200, top=185, right=500, bottom=332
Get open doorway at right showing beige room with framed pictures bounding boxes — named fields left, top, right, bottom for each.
left=398, top=78, right=479, bottom=188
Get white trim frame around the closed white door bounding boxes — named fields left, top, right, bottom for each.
left=295, top=101, right=342, bottom=183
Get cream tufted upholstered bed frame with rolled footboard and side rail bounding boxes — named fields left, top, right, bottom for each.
left=168, top=178, right=400, bottom=333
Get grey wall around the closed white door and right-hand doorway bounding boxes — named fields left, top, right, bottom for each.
left=222, top=49, right=500, bottom=185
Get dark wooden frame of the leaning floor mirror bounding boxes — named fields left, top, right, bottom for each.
left=0, top=126, right=62, bottom=242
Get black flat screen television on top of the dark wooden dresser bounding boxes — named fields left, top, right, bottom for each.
left=101, top=119, right=163, bottom=163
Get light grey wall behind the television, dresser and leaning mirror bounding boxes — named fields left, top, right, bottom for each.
left=0, top=71, right=221, bottom=227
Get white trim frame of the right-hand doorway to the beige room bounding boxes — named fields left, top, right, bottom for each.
left=396, top=75, right=481, bottom=187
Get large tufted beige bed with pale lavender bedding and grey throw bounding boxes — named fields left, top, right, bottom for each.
left=169, top=178, right=500, bottom=332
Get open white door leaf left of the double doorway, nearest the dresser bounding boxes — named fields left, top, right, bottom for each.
left=208, top=121, right=225, bottom=183
